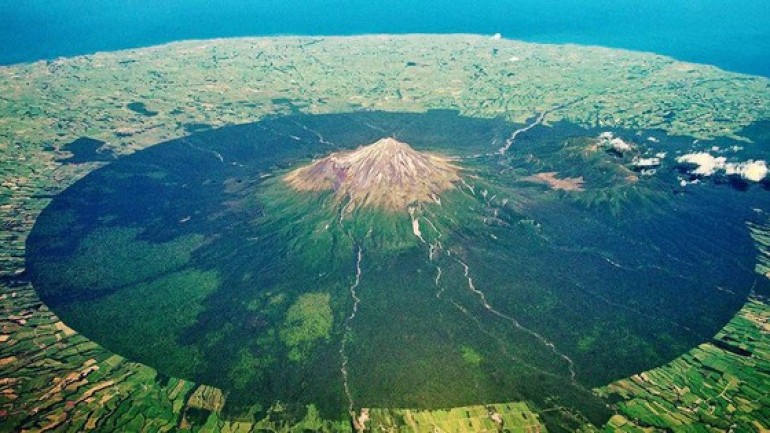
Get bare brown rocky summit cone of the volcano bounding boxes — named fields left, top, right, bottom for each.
left=284, top=137, right=460, bottom=211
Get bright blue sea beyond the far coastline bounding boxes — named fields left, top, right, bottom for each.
left=0, top=0, right=770, bottom=76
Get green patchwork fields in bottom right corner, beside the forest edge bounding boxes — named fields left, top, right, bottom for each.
left=598, top=300, right=770, bottom=432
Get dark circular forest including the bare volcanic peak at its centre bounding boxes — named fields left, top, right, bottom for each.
left=27, top=111, right=768, bottom=423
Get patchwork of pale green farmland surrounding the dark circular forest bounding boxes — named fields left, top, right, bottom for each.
left=0, top=36, right=770, bottom=431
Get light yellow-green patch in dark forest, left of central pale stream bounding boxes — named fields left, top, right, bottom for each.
left=281, top=293, right=332, bottom=362
